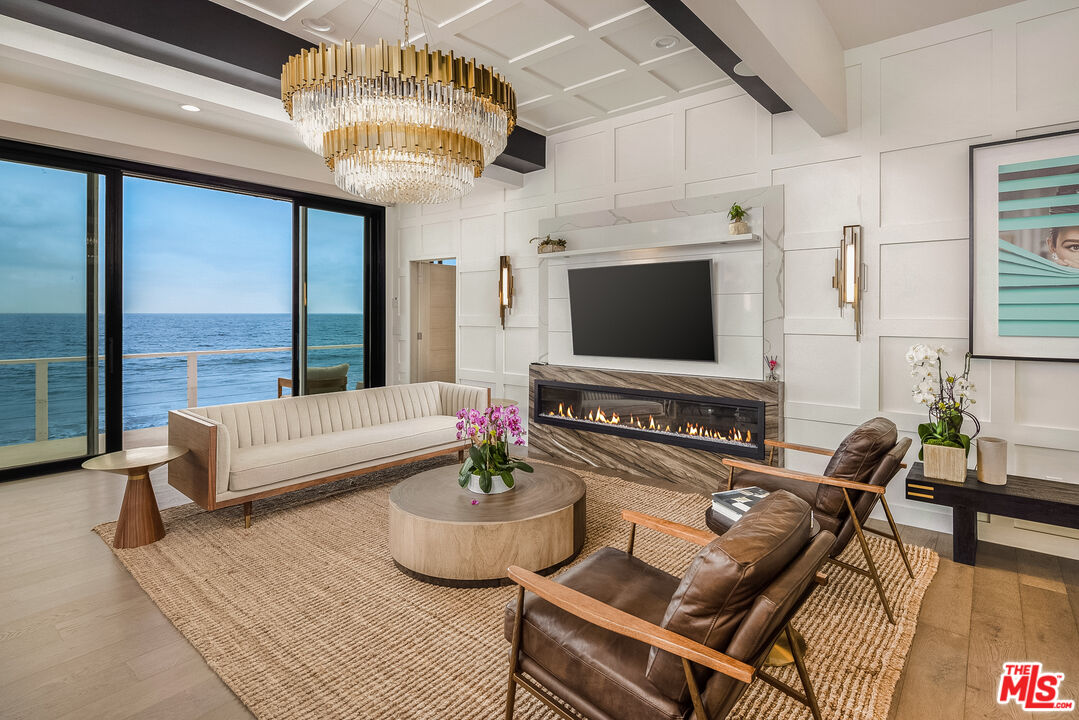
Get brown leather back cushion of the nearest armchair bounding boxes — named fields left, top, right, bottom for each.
left=647, top=490, right=811, bottom=702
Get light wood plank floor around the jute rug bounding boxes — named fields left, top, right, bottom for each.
left=0, top=444, right=1079, bottom=720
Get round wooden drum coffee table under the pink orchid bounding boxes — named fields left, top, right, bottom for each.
left=390, top=464, right=585, bottom=587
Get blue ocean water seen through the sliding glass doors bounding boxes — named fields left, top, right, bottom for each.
left=0, top=313, right=364, bottom=445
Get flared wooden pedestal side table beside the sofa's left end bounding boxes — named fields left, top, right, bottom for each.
left=82, top=445, right=188, bottom=547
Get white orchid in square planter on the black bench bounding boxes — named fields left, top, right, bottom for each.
left=906, top=344, right=982, bottom=483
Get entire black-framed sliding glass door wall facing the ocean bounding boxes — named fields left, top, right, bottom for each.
left=0, top=138, right=385, bottom=480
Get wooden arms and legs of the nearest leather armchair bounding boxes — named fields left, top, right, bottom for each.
left=505, top=510, right=828, bottom=720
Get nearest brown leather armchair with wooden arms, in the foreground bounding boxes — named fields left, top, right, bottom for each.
left=505, top=492, right=834, bottom=720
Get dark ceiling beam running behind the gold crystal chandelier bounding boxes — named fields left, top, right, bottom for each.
left=0, top=0, right=546, bottom=173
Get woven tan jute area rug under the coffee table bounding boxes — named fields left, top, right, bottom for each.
left=95, top=464, right=938, bottom=720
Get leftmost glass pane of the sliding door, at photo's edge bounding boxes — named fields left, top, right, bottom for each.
left=0, top=161, right=105, bottom=471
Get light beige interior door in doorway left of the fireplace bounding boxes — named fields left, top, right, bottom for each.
left=411, top=261, right=457, bottom=382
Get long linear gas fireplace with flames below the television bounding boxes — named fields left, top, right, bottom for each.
left=532, top=380, right=765, bottom=460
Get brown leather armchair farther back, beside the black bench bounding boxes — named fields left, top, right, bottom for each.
left=707, top=418, right=914, bottom=624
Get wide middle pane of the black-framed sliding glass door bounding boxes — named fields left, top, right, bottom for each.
left=123, top=176, right=292, bottom=433
